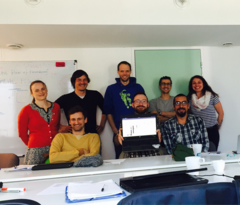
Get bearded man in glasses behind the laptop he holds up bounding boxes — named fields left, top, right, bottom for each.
left=114, top=91, right=167, bottom=158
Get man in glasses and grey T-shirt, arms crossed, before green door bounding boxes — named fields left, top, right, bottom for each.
left=148, top=76, right=175, bottom=123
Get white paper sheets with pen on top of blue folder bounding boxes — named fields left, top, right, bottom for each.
left=68, top=180, right=122, bottom=200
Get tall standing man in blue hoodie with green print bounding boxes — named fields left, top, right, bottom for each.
left=104, top=61, right=144, bottom=159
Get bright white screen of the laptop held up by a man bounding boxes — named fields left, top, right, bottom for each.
left=122, top=114, right=156, bottom=137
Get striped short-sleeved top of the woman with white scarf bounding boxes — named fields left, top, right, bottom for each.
left=189, top=95, right=220, bottom=128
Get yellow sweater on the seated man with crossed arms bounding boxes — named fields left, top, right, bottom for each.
left=49, top=133, right=100, bottom=163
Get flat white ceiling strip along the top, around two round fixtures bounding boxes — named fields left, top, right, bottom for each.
left=0, top=0, right=240, bottom=25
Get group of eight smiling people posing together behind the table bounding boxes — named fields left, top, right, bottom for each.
left=18, top=61, right=224, bottom=164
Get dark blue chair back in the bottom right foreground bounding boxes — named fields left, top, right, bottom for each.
left=118, top=180, right=240, bottom=205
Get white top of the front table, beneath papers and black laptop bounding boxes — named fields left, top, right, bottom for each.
left=0, top=163, right=240, bottom=205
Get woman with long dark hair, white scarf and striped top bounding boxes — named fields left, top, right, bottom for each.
left=188, top=75, right=224, bottom=149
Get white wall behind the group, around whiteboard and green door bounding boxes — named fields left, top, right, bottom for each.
left=0, top=47, right=240, bottom=159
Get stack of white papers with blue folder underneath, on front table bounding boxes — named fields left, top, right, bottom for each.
left=66, top=180, right=126, bottom=203
